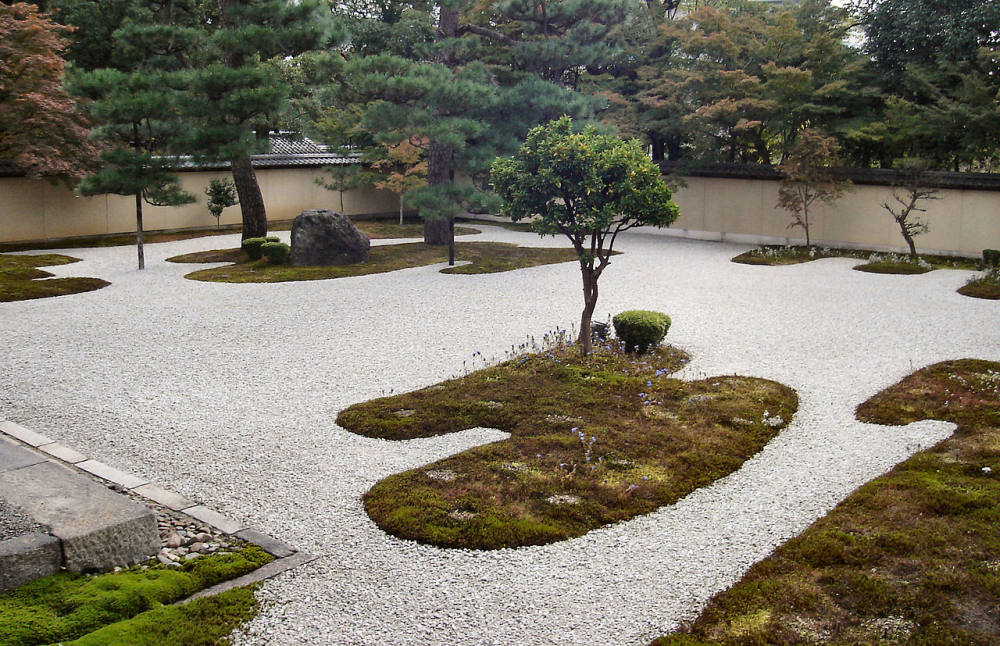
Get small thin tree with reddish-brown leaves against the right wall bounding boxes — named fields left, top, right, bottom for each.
left=777, top=128, right=851, bottom=247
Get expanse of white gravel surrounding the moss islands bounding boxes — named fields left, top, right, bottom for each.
left=0, top=227, right=1000, bottom=645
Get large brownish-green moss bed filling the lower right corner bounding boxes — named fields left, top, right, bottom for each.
left=653, top=359, right=1000, bottom=646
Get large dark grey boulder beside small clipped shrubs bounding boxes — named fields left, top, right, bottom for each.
left=291, top=209, right=371, bottom=266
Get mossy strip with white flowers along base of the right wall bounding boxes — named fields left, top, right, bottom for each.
left=732, top=245, right=982, bottom=274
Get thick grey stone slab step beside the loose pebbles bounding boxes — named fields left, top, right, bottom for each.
left=0, top=461, right=160, bottom=572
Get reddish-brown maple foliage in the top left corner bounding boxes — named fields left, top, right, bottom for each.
left=0, top=3, right=97, bottom=178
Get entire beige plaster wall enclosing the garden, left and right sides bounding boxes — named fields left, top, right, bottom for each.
left=0, top=168, right=1000, bottom=256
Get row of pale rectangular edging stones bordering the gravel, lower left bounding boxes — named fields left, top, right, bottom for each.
left=0, top=420, right=296, bottom=564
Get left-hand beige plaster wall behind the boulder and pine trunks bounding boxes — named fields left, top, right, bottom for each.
left=0, top=168, right=399, bottom=242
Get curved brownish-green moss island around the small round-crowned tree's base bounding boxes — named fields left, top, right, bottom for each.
left=337, top=344, right=798, bottom=550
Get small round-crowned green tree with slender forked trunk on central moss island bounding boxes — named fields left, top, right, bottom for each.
left=491, top=116, right=678, bottom=355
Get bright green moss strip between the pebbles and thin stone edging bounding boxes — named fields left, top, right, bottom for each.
left=0, top=545, right=274, bottom=646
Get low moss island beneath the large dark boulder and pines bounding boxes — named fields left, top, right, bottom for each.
left=169, top=242, right=577, bottom=283
